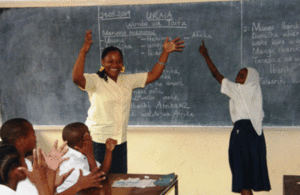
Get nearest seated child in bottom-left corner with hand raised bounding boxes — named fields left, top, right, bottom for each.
left=0, top=142, right=52, bottom=195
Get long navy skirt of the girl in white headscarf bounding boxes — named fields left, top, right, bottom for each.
left=229, top=120, right=271, bottom=192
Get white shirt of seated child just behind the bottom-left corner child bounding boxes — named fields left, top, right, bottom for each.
left=15, top=158, right=39, bottom=195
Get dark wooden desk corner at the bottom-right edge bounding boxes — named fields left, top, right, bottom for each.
left=283, top=175, right=300, bottom=195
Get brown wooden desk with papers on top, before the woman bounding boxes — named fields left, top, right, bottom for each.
left=78, top=174, right=178, bottom=195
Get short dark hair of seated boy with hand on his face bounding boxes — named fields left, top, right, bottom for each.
left=62, top=122, right=88, bottom=148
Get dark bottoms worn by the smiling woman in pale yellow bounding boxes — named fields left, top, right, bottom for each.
left=93, top=142, right=127, bottom=173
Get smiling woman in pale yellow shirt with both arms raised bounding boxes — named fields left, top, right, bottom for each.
left=72, top=31, right=184, bottom=173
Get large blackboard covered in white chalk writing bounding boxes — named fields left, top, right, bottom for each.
left=0, top=0, right=300, bottom=126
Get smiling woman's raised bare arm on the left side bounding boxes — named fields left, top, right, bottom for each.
left=72, top=30, right=93, bottom=89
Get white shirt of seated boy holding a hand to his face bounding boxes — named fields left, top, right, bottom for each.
left=56, top=148, right=101, bottom=193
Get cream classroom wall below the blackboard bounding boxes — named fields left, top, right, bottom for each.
left=35, top=127, right=300, bottom=195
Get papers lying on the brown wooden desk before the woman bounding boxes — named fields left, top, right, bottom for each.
left=112, top=178, right=156, bottom=188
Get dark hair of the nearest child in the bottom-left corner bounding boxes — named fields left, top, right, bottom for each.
left=0, top=142, right=22, bottom=184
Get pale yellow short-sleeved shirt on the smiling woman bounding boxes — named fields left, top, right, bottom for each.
left=84, top=73, right=148, bottom=144
